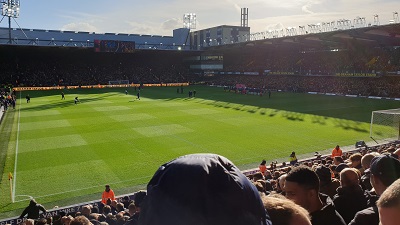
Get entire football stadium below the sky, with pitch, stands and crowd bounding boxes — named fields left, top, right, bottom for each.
left=0, top=1, right=400, bottom=225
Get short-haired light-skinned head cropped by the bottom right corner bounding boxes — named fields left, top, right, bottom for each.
left=376, top=179, right=400, bottom=225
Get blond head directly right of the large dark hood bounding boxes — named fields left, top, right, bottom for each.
left=262, top=195, right=311, bottom=225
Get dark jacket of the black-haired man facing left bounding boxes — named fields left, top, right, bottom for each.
left=310, top=194, right=346, bottom=225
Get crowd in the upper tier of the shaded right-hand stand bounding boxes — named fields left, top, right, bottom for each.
left=224, top=46, right=400, bottom=75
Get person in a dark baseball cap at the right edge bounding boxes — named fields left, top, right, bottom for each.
left=349, top=155, right=400, bottom=225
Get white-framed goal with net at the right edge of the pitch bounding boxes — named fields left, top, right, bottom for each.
left=370, top=109, right=400, bottom=141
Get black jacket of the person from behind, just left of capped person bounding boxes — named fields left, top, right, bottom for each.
left=333, top=185, right=368, bottom=223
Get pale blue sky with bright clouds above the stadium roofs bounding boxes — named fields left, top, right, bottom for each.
left=0, top=0, right=400, bottom=36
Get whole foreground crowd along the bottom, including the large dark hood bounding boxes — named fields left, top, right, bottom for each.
left=17, top=144, right=400, bottom=225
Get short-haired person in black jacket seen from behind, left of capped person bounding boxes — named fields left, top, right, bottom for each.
left=333, top=168, right=368, bottom=223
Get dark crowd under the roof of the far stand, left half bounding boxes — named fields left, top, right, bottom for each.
left=0, top=46, right=198, bottom=86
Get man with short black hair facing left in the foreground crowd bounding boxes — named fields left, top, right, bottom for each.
left=285, top=166, right=346, bottom=225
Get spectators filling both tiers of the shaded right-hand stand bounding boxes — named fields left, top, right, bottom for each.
left=208, top=46, right=400, bottom=97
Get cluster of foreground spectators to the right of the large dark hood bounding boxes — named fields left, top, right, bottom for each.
left=249, top=143, right=400, bottom=225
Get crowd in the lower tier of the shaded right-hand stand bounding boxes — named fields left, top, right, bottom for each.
left=210, top=75, right=400, bottom=97
